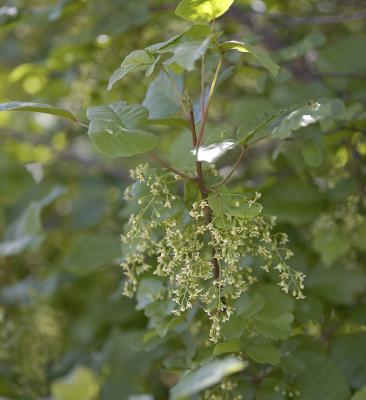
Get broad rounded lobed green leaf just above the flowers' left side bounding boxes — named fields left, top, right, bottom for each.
left=87, top=102, right=159, bottom=157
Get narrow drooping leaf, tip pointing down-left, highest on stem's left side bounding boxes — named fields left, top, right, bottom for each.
left=107, top=50, right=155, bottom=90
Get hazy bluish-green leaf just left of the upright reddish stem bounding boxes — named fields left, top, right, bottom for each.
left=142, top=71, right=183, bottom=120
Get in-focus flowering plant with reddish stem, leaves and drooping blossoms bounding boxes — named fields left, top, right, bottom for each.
left=0, top=0, right=361, bottom=399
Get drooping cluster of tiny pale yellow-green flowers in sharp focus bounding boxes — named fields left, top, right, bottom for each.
left=122, top=165, right=304, bottom=341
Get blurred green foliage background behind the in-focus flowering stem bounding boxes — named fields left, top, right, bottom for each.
left=0, top=0, right=366, bottom=400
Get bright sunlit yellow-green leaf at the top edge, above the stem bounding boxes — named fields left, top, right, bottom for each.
left=175, top=0, right=234, bottom=23
